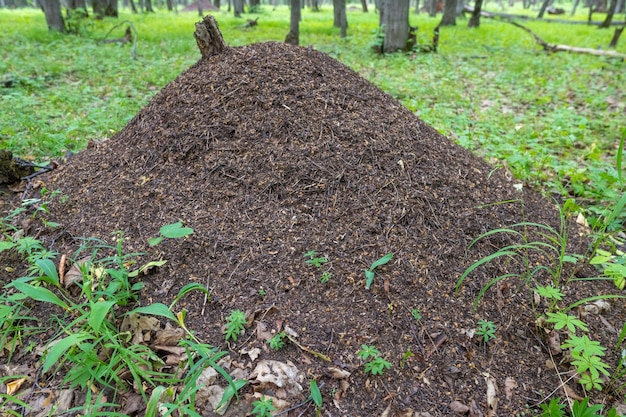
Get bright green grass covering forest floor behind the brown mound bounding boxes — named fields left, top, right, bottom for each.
left=0, top=6, right=626, bottom=210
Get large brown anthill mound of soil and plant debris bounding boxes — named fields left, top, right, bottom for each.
left=2, top=39, right=626, bottom=416
